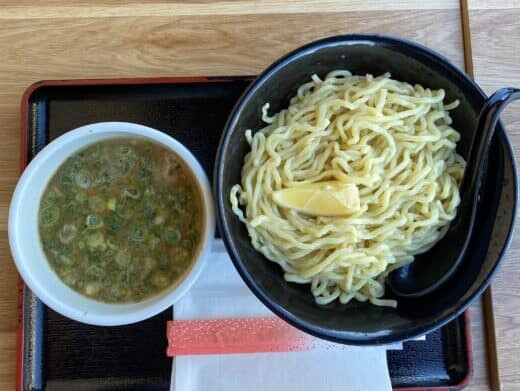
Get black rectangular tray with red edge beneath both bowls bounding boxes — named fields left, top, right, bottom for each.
left=20, top=77, right=471, bottom=391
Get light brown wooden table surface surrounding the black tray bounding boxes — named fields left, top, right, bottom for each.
left=0, top=0, right=520, bottom=390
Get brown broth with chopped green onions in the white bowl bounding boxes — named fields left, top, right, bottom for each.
left=39, top=138, right=203, bottom=302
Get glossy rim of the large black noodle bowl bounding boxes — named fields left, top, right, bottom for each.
left=213, top=34, right=518, bottom=345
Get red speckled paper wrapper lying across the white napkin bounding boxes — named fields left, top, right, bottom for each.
left=166, top=317, right=314, bottom=357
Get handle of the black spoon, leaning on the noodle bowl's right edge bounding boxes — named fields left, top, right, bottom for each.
left=459, top=87, right=520, bottom=227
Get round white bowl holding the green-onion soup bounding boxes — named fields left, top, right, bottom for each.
left=9, top=122, right=215, bottom=326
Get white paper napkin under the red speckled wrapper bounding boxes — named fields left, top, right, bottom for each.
left=171, top=242, right=394, bottom=391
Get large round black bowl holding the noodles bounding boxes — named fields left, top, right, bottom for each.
left=214, top=35, right=517, bottom=345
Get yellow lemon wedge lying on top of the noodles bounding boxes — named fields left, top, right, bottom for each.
left=273, top=181, right=360, bottom=216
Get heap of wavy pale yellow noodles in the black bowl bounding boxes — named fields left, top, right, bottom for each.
left=230, top=70, right=465, bottom=307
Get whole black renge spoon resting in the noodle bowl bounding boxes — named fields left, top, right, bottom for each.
left=386, top=88, right=520, bottom=297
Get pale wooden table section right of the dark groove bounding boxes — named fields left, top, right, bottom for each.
left=469, top=0, right=520, bottom=390
